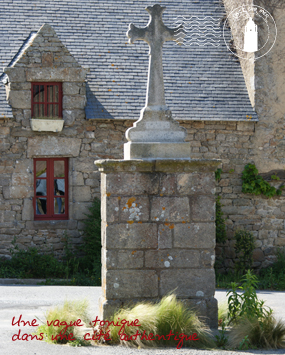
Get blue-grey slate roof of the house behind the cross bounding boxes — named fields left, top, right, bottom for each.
left=0, top=0, right=257, bottom=120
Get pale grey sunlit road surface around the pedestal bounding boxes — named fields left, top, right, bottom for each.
left=0, top=285, right=285, bottom=355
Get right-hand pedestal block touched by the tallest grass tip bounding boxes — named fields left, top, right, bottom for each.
left=160, top=269, right=215, bottom=298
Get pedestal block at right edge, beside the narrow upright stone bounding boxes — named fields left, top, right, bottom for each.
left=173, top=222, right=216, bottom=249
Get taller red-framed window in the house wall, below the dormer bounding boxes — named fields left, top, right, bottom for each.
left=34, top=158, right=68, bottom=220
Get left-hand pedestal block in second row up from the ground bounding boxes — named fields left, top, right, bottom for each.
left=105, top=270, right=158, bottom=299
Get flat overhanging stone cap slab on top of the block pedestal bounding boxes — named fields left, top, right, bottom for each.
left=94, top=159, right=221, bottom=174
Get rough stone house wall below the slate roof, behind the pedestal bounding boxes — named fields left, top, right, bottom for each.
left=0, top=115, right=285, bottom=267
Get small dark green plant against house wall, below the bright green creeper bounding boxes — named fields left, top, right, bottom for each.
left=234, top=230, right=255, bottom=274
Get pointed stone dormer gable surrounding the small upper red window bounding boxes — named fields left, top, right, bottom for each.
left=4, top=24, right=87, bottom=126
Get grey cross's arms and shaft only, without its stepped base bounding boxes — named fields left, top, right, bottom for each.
left=127, top=4, right=183, bottom=107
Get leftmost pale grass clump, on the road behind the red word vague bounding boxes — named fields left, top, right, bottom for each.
left=36, top=300, right=90, bottom=346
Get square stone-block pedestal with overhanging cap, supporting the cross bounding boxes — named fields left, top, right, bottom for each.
left=95, top=159, right=220, bottom=327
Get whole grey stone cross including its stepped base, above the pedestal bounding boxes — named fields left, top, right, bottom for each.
left=124, top=4, right=190, bottom=160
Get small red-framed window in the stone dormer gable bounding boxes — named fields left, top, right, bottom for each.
left=31, top=83, right=62, bottom=118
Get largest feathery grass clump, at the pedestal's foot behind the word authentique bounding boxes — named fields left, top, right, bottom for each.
left=110, top=295, right=214, bottom=349
